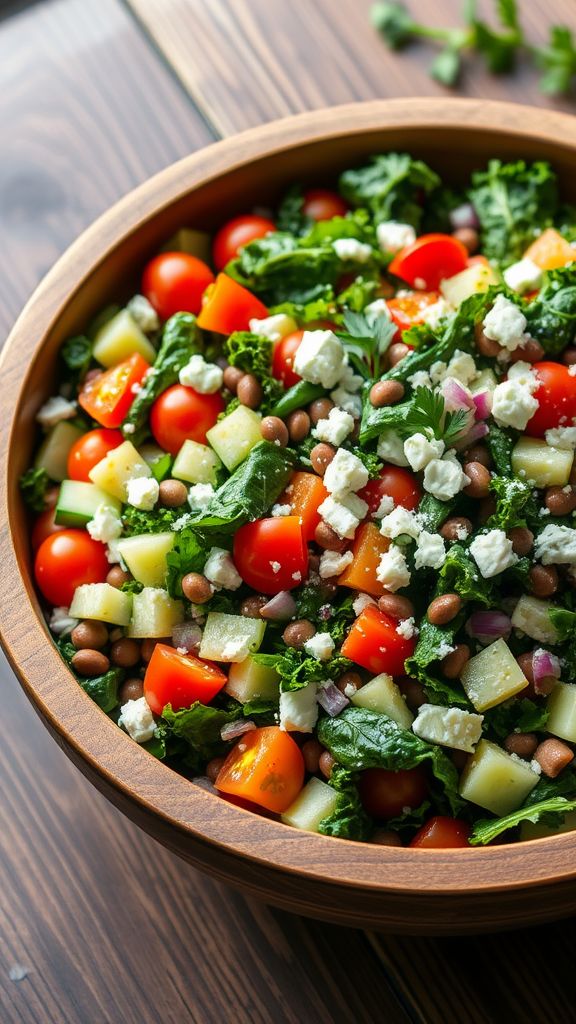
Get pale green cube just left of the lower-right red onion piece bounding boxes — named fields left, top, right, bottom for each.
left=460, top=640, right=528, bottom=711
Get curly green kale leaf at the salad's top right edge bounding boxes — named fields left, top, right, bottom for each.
left=469, top=160, right=559, bottom=265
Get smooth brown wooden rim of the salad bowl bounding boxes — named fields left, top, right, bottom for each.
left=0, top=97, right=576, bottom=896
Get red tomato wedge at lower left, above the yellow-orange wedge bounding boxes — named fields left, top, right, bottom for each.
left=143, top=643, right=227, bottom=715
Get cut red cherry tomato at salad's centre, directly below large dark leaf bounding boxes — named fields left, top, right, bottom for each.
left=234, top=515, right=308, bottom=594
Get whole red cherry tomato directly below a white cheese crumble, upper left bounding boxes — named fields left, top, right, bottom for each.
left=150, top=384, right=224, bottom=455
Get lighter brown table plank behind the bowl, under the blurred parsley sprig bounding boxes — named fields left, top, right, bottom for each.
left=128, top=0, right=576, bottom=134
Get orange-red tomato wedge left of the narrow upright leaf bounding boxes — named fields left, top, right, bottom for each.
left=78, top=352, right=150, bottom=427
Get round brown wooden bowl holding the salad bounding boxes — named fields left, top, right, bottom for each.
left=0, top=99, right=576, bottom=934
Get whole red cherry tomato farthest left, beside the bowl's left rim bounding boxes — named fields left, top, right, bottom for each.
left=34, top=529, right=110, bottom=607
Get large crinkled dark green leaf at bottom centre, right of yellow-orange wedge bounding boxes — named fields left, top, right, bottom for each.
left=318, top=708, right=463, bottom=814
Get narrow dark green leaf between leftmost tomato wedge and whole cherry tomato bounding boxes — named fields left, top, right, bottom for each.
left=122, top=313, right=203, bottom=445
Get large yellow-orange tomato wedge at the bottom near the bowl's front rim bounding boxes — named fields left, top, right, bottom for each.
left=214, top=725, right=304, bottom=814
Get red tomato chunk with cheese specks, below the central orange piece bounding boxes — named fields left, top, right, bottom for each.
left=342, top=604, right=416, bottom=676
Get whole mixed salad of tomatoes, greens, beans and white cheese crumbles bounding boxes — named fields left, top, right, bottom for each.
left=22, top=154, right=576, bottom=848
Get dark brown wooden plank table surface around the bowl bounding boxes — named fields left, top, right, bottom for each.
left=0, top=0, right=576, bottom=1024
